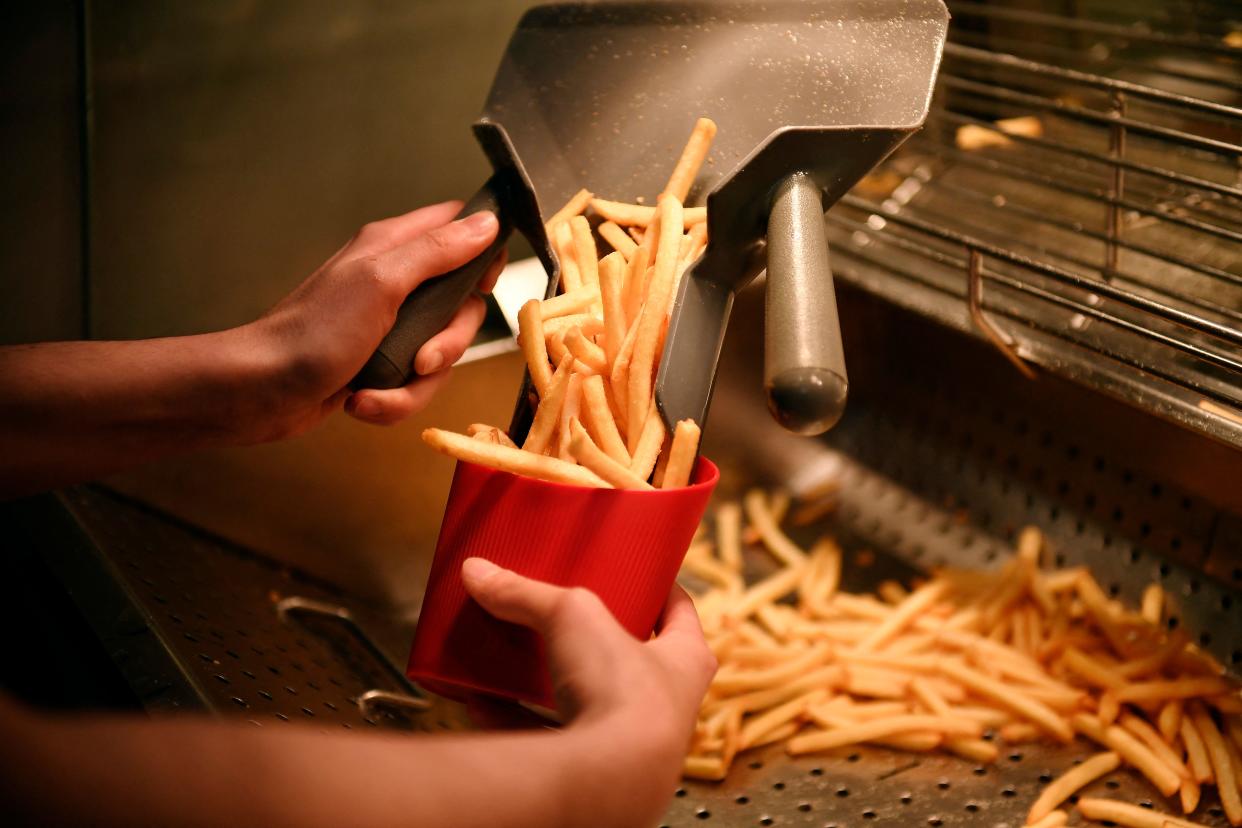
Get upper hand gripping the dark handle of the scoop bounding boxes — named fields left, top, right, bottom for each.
left=240, top=201, right=505, bottom=442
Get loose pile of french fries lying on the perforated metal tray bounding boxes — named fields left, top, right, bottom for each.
left=684, top=490, right=1242, bottom=828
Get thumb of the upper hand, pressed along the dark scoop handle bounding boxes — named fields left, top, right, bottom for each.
left=376, top=211, right=501, bottom=299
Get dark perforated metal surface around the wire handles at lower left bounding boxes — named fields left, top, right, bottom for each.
left=57, top=489, right=465, bottom=730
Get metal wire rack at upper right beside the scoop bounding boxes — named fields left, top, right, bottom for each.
left=828, top=2, right=1242, bottom=454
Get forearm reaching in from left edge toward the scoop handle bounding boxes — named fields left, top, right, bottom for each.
left=0, top=328, right=277, bottom=497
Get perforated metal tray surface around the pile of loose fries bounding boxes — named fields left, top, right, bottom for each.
left=662, top=361, right=1242, bottom=828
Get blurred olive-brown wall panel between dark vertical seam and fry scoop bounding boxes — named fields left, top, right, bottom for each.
left=91, top=0, right=529, bottom=338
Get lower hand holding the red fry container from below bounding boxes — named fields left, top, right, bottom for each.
left=462, top=557, right=715, bottom=804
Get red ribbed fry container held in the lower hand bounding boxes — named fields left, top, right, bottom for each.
left=406, top=458, right=720, bottom=708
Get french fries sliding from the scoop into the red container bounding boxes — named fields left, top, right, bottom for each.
left=422, top=118, right=717, bottom=489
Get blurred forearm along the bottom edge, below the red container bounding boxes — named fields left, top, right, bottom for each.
left=7, top=705, right=673, bottom=828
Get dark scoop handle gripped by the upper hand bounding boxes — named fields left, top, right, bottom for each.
left=349, top=175, right=513, bottom=390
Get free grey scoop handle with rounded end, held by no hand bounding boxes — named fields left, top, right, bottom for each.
left=764, top=174, right=848, bottom=434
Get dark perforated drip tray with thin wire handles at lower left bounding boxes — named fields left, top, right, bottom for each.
left=47, top=488, right=467, bottom=731
